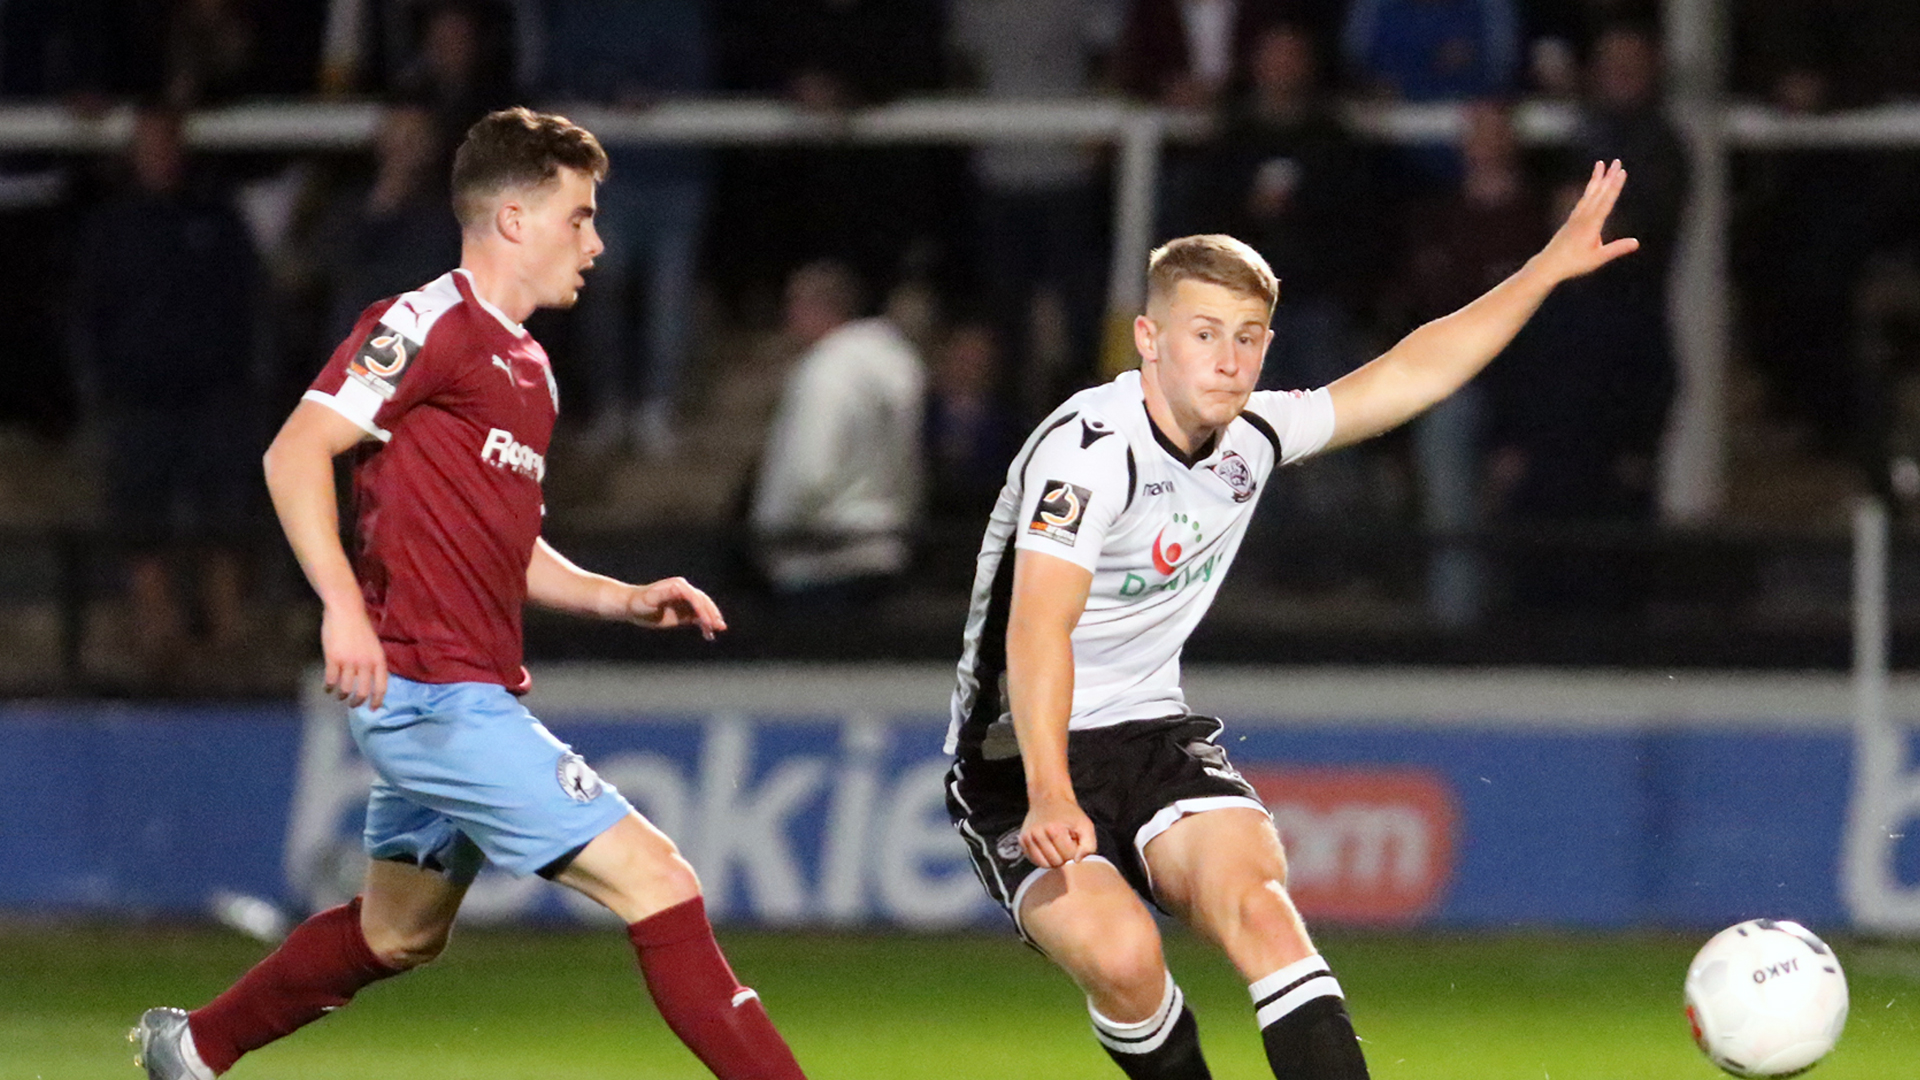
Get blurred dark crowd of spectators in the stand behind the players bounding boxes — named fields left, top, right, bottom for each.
left=0, top=0, right=1920, bottom=680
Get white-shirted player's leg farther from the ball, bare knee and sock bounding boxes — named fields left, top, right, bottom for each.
left=1020, top=859, right=1210, bottom=1080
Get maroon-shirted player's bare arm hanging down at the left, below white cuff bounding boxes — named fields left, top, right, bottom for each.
left=265, top=402, right=386, bottom=709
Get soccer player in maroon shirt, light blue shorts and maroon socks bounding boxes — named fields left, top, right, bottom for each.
left=131, top=110, right=801, bottom=1080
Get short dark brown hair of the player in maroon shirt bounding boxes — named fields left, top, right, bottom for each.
left=453, top=106, right=607, bottom=229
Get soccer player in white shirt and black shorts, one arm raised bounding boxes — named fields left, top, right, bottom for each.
left=947, top=161, right=1640, bottom=1080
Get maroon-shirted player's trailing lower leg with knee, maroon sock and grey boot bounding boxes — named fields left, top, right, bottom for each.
left=134, top=861, right=467, bottom=1080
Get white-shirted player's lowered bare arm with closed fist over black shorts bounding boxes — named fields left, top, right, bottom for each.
left=1006, top=552, right=1094, bottom=867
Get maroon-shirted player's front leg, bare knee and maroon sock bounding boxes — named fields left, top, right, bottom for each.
left=553, top=815, right=803, bottom=1080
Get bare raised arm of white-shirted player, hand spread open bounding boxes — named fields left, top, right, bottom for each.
left=1327, top=161, right=1640, bottom=450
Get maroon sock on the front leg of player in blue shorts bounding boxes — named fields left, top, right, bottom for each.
left=625, top=897, right=804, bottom=1080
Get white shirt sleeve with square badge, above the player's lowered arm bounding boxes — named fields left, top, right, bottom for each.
left=1014, top=411, right=1133, bottom=571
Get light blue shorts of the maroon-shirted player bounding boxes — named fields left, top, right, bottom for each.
left=349, top=675, right=634, bottom=882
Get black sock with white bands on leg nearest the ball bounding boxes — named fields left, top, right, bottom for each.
left=1248, top=953, right=1367, bottom=1080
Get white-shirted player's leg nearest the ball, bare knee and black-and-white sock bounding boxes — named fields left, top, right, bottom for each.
left=1146, top=807, right=1367, bottom=1080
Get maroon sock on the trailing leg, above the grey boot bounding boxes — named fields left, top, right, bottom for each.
left=186, top=897, right=401, bottom=1072
